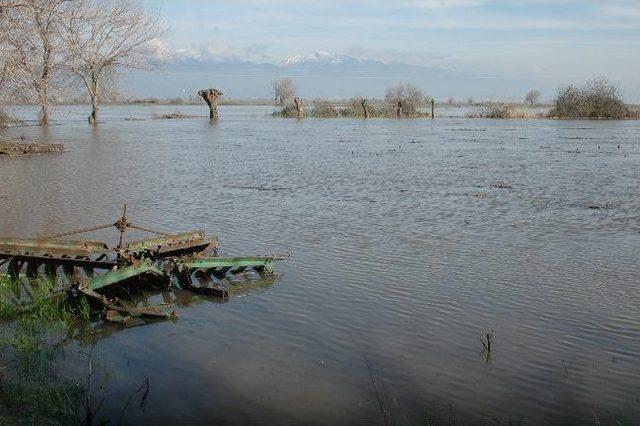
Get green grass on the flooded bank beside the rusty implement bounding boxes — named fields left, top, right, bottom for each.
left=0, top=275, right=90, bottom=425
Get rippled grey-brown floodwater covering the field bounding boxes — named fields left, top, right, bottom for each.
left=0, top=106, right=640, bottom=425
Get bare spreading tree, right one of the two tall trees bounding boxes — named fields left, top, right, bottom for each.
left=63, top=0, right=166, bottom=123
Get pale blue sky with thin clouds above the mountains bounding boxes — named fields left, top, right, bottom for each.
left=145, top=0, right=640, bottom=101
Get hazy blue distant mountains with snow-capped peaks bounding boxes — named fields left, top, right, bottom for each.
left=121, top=52, right=534, bottom=100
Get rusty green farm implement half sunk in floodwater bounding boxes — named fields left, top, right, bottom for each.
left=0, top=206, right=286, bottom=322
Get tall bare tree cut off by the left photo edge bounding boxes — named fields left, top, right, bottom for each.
left=0, top=0, right=65, bottom=125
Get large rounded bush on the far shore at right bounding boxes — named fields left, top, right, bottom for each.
left=548, top=78, right=634, bottom=119
